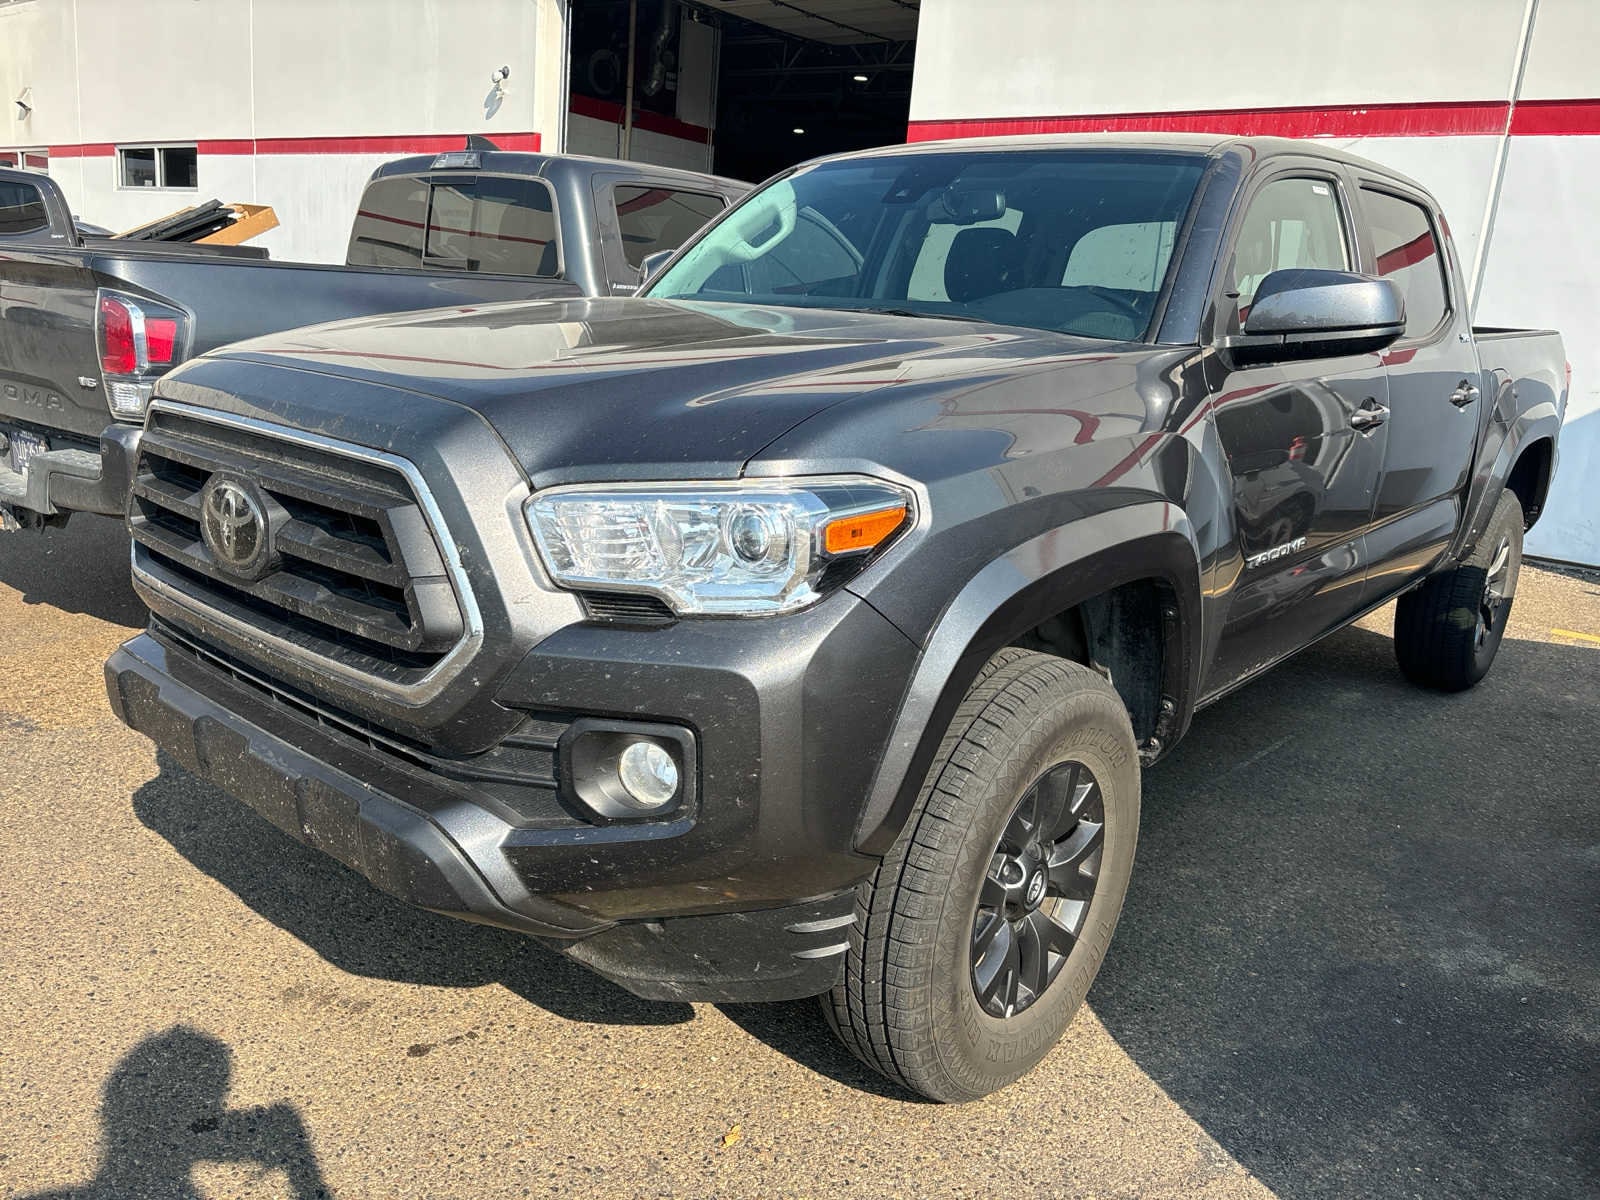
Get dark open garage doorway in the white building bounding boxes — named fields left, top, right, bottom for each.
left=566, top=0, right=918, bottom=181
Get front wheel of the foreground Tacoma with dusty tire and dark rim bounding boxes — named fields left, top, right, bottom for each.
left=822, top=650, right=1139, bottom=1102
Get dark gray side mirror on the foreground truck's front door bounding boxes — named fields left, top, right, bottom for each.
left=1222, top=267, right=1405, bottom=366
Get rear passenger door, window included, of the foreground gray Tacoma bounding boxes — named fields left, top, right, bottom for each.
left=1358, top=179, right=1483, bottom=600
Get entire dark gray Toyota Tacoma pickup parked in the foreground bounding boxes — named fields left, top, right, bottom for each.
left=106, top=136, right=1568, bottom=1101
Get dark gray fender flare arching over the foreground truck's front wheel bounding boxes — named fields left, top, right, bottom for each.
left=854, top=499, right=1202, bottom=858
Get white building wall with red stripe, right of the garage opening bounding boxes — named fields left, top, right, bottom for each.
left=910, top=0, right=1600, bottom=565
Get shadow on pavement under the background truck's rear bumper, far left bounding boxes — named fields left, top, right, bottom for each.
left=0, top=514, right=149, bottom=629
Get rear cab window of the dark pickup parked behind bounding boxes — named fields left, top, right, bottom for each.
left=346, top=176, right=560, bottom=278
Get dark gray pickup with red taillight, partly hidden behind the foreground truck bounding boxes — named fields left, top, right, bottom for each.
left=0, top=150, right=749, bottom=528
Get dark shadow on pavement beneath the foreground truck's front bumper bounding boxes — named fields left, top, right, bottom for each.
left=133, top=752, right=694, bottom=1026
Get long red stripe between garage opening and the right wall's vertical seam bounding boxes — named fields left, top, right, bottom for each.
left=906, top=101, right=1510, bottom=142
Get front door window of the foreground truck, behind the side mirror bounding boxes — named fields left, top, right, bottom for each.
left=1229, top=179, right=1350, bottom=331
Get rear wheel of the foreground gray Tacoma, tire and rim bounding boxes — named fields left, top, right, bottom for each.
left=1395, top=491, right=1523, bottom=691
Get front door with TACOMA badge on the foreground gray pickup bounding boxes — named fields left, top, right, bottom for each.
left=1206, top=160, right=1387, bottom=693
